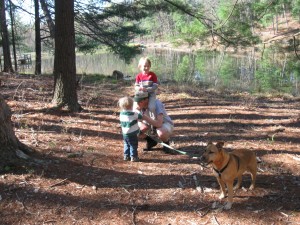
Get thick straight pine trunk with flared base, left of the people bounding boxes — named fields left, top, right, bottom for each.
left=52, top=0, right=82, bottom=112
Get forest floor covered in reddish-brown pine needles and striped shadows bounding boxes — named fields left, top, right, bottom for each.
left=0, top=76, right=300, bottom=225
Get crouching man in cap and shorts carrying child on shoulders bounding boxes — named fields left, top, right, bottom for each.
left=133, top=92, right=174, bottom=153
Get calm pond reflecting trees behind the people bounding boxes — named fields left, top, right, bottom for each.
left=20, top=49, right=300, bottom=96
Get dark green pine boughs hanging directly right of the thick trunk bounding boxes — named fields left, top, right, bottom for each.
left=75, top=2, right=151, bottom=62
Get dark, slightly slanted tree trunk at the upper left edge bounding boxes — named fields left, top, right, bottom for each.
left=0, top=0, right=14, bottom=72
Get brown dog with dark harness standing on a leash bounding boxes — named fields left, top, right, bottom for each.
left=202, top=142, right=257, bottom=209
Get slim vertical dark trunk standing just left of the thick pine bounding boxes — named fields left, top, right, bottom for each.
left=34, top=0, right=42, bottom=75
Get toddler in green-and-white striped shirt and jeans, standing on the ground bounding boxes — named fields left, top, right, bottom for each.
left=119, top=97, right=143, bottom=162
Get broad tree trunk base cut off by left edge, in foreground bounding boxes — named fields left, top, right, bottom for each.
left=0, top=95, right=30, bottom=171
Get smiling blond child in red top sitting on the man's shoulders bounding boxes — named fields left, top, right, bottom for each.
left=135, top=57, right=158, bottom=117
